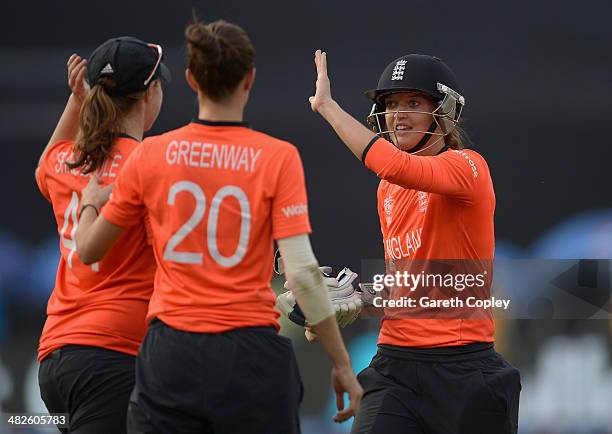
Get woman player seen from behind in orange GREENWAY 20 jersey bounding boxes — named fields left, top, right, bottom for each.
left=77, top=21, right=362, bottom=434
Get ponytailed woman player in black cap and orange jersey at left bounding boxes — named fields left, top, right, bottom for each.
left=36, top=37, right=168, bottom=433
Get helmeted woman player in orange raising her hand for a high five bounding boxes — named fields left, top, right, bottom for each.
left=310, top=50, right=520, bottom=434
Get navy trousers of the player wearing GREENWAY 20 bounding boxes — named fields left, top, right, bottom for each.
left=128, top=320, right=302, bottom=434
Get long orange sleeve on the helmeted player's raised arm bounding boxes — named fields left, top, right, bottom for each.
left=364, top=138, right=482, bottom=202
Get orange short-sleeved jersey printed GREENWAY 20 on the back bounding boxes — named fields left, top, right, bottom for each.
left=102, top=120, right=310, bottom=333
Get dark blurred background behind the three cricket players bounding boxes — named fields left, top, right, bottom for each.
left=0, top=0, right=612, bottom=434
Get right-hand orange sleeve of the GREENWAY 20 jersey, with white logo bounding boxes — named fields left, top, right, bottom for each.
left=272, top=146, right=311, bottom=240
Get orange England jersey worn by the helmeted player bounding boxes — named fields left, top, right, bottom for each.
left=364, top=139, right=495, bottom=347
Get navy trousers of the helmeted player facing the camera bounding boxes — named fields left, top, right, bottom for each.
left=351, top=343, right=521, bottom=434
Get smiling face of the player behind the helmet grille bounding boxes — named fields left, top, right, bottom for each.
left=384, top=91, right=440, bottom=151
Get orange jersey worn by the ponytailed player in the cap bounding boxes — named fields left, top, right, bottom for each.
left=36, top=137, right=155, bottom=360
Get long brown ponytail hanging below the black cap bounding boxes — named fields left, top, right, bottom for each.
left=66, top=77, right=142, bottom=174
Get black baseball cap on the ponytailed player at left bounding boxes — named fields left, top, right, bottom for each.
left=87, top=36, right=171, bottom=96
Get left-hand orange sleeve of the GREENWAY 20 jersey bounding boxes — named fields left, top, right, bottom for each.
left=102, top=143, right=145, bottom=228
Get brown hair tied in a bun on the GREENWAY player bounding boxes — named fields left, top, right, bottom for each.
left=185, top=16, right=255, bottom=101
